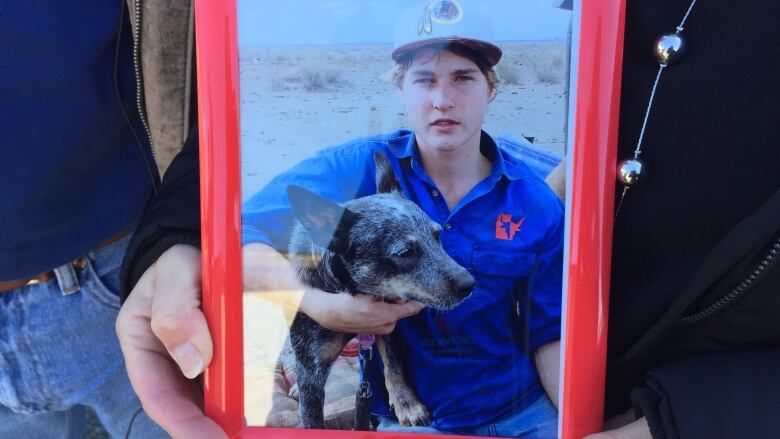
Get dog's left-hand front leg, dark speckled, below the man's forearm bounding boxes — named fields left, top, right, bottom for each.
left=290, top=314, right=351, bottom=429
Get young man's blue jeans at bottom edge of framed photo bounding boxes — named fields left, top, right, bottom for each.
left=376, top=395, right=558, bottom=439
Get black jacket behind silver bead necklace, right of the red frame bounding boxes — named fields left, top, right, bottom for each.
left=606, top=0, right=780, bottom=438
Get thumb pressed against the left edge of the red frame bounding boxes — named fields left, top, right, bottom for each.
left=151, top=245, right=213, bottom=379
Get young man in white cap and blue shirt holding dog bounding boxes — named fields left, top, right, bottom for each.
left=243, top=1, right=563, bottom=437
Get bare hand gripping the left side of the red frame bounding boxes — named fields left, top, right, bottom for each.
left=116, top=245, right=227, bottom=439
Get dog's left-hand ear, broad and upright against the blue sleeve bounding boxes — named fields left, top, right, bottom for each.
left=287, top=185, right=358, bottom=253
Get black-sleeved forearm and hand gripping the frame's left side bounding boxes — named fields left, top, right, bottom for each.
left=116, top=127, right=225, bottom=439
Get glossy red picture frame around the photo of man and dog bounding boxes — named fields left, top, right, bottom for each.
left=196, top=0, right=625, bottom=439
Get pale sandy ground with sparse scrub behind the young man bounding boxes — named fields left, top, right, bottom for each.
left=239, top=42, right=566, bottom=425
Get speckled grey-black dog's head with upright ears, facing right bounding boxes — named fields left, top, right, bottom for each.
left=287, top=152, right=475, bottom=309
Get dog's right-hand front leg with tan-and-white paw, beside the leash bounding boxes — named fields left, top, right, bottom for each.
left=376, top=336, right=431, bottom=427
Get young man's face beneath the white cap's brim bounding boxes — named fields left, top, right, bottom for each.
left=398, top=49, right=491, bottom=152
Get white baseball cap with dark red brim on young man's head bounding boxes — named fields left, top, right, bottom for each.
left=392, top=0, right=501, bottom=67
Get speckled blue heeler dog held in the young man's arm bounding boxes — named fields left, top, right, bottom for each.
left=287, top=152, right=474, bottom=428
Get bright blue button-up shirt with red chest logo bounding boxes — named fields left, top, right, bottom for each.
left=243, top=131, right=564, bottom=431
